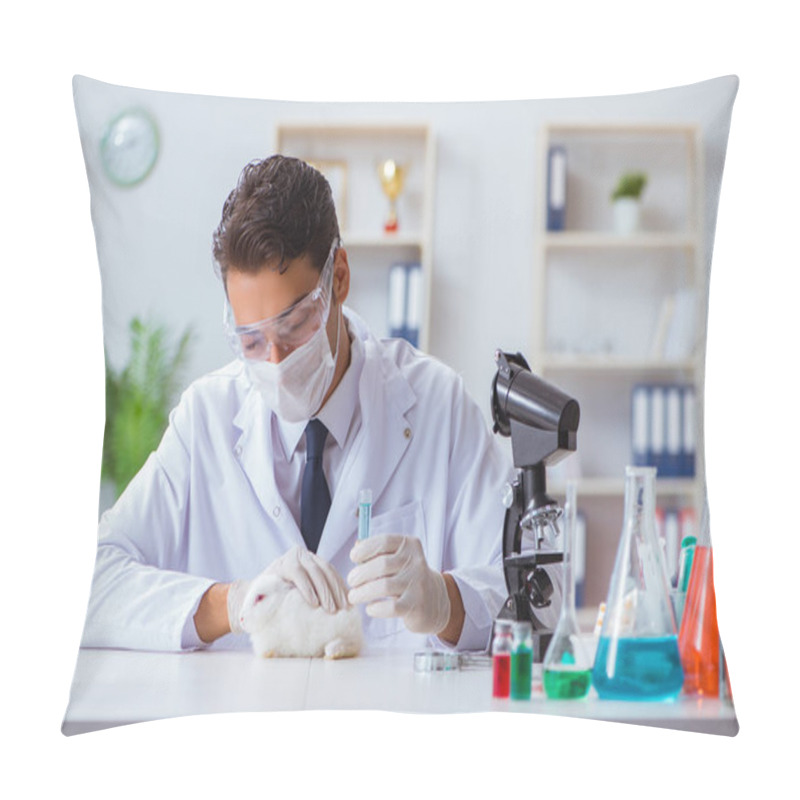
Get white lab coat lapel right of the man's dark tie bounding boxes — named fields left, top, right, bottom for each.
left=317, top=337, right=416, bottom=561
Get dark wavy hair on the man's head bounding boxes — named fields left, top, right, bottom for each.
left=213, top=155, right=339, bottom=285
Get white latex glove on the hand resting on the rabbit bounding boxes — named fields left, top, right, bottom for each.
left=228, top=545, right=349, bottom=633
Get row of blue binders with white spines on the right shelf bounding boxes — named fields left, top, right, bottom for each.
left=631, top=383, right=696, bottom=478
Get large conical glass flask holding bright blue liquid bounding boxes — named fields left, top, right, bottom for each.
left=592, top=467, right=683, bottom=700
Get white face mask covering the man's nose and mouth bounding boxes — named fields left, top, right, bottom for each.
left=245, top=309, right=342, bottom=422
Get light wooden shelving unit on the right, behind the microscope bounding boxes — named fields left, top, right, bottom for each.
left=530, top=123, right=707, bottom=605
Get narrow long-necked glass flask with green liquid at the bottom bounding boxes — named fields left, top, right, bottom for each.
left=542, top=481, right=592, bottom=700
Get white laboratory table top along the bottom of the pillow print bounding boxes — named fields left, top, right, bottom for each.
left=62, top=648, right=739, bottom=736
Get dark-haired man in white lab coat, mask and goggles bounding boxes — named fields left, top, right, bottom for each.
left=83, top=156, right=560, bottom=650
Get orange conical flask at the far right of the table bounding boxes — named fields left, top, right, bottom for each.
left=678, top=545, right=720, bottom=697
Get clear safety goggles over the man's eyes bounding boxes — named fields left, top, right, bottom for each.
left=223, top=241, right=338, bottom=361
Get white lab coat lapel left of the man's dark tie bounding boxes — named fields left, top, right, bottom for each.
left=233, top=391, right=304, bottom=549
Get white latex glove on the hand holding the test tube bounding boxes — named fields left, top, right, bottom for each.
left=347, top=534, right=450, bottom=633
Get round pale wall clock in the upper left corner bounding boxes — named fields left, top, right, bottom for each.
left=100, top=108, right=159, bottom=186
